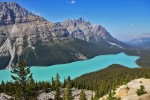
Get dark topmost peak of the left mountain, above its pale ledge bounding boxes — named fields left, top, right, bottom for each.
left=0, top=2, right=39, bottom=25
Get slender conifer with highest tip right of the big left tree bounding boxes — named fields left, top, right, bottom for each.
left=55, top=73, right=61, bottom=100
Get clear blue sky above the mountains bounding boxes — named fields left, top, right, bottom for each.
left=1, top=0, right=150, bottom=41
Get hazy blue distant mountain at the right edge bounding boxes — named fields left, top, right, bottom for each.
left=127, top=33, right=150, bottom=48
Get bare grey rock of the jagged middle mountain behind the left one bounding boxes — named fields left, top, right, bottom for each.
left=61, top=18, right=127, bottom=48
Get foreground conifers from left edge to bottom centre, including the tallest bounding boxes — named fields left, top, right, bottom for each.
left=0, top=61, right=86, bottom=100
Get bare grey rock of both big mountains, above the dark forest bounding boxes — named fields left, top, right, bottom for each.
left=0, top=2, right=129, bottom=68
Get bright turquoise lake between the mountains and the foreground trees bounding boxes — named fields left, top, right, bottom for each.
left=0, top=53, right=139, bottom=82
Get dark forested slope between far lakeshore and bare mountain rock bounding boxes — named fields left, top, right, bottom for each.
left=20, top=39, right=122, bottom=66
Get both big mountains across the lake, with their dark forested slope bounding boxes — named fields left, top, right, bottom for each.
left=0, top=2, right=130, bottom=69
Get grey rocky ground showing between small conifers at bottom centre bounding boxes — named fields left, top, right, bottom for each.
left=37, top=88, right=95, bottom=100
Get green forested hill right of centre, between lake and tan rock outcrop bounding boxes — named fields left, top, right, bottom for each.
left=73, top=64, right=150, bottom=98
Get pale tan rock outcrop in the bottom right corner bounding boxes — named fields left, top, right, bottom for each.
left=100, top=78, right=150, bottom=100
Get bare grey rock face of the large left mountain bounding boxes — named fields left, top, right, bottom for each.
left=0, top=2, right=69, bottom=68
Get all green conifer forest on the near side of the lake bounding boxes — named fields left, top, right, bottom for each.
left=0, top=61, right=150, bottom=100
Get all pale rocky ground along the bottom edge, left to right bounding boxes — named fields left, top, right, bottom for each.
left=0, top=78, right=150, bottom=100
